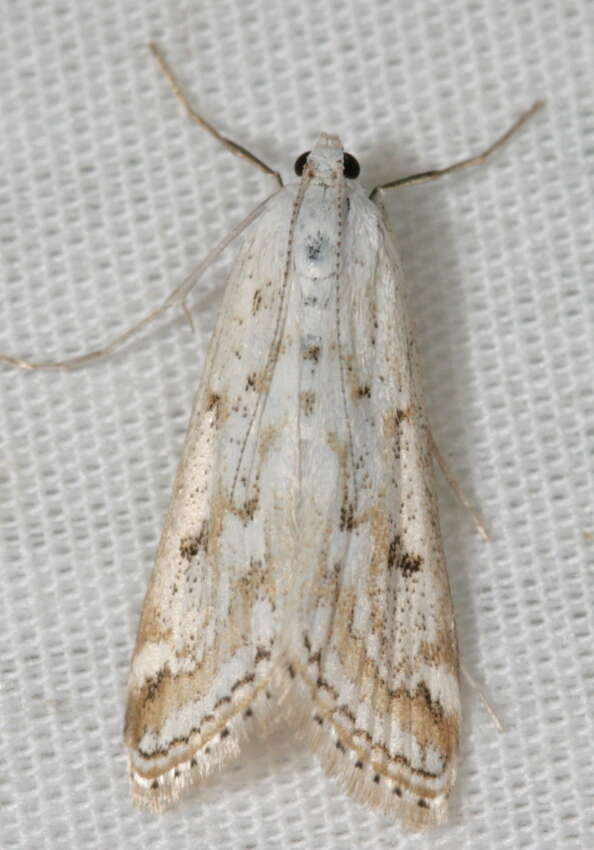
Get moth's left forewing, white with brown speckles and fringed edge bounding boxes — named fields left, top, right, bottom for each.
left=125, top=190, right=296, bottom=809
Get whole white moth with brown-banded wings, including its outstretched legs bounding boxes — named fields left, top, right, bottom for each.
left=2, top=46, right=542, bottom=829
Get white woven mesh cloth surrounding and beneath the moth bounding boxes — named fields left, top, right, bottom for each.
left=0, top=0, right=594, bottom=850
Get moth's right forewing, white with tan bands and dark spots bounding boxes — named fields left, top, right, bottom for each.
left=289, top=193, right=460, bottom=828
